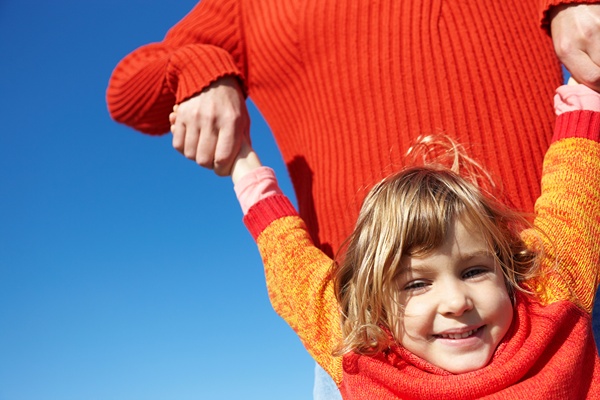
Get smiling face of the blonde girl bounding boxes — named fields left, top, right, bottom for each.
left=392, top=220, right=513, bottom=374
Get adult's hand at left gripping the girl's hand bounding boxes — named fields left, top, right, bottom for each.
left=169, top=76, right=250, bottom=176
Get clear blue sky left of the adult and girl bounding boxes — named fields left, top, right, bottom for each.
left=0, top=0, right=313, bottom=400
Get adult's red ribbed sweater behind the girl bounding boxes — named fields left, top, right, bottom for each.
left=107, top=0, right=584, bottom=254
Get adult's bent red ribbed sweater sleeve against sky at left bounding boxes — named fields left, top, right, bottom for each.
left=106, top=0, right=247, bottom=134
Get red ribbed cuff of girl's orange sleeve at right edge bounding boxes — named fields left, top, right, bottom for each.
left=552, top=110, right=600, bottom=143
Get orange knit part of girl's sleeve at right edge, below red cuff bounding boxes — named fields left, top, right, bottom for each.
left=524, top=138, right=600, bottom=313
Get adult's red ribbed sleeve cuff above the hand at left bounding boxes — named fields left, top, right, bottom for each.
left=167, top=44, right=248, bottom=104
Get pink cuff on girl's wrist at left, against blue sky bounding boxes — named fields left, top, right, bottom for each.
left=233, top=167, right=281, bottom=215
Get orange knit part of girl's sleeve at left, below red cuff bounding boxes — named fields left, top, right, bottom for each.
left=256, top=216, right=342, bottom=384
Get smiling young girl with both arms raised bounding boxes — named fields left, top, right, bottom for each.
left=191, top=82, right=600, bottom=400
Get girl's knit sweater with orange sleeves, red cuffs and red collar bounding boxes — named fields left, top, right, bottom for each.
left=245, top=111, right=600, bottom=400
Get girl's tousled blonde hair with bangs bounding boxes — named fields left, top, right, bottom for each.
left=334, top=136, right=538, bottom=355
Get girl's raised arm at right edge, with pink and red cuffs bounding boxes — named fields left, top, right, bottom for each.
left=525, top=85, right=600, bottom=313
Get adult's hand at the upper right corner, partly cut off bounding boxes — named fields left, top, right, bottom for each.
left=550, top=4, right=600, bottom=91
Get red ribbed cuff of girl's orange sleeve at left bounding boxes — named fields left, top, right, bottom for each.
left=244, top=194, right=298, bottom=240
